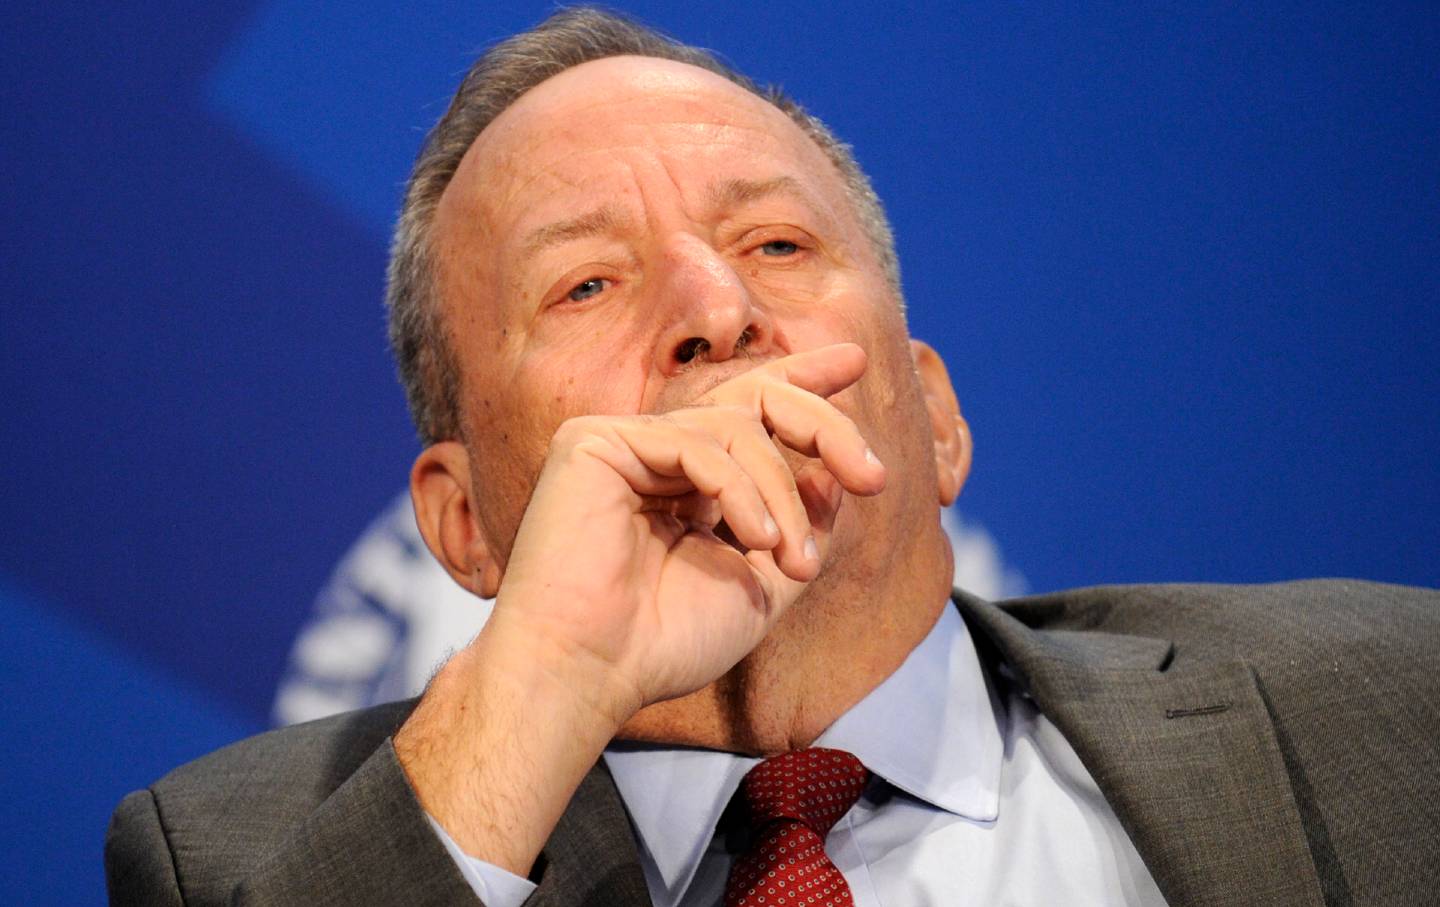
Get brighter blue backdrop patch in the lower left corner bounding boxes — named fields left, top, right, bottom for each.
left=0, top=579, right=262, bottom=907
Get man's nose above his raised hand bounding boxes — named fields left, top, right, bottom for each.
left=655, top=236, right=773, bottom=376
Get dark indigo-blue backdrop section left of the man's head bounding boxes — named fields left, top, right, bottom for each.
left=0, top=4, right=412, bottom=716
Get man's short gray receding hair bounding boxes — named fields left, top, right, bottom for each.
left=386, top=7, right=901, bottom=445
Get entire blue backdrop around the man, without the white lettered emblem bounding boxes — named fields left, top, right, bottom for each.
left=0, top=0, right=1440, bottom=904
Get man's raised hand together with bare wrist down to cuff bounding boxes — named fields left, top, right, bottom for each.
left=396, top=344, right=884, bottom=874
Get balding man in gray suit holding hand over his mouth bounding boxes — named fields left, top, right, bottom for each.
left=107, top=12, right=1440, bottom=907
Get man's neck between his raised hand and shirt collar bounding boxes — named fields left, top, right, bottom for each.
left=619, top=511, right=953, bottom=756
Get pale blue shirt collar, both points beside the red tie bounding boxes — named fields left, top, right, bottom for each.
left=605, top=606, right=1005, bottom=904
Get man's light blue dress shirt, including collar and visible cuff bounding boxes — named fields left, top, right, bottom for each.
left=435, top=608, right=1165, bottom=907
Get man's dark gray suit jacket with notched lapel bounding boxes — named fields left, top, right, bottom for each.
left=105, top=582, right=1440, bottom=907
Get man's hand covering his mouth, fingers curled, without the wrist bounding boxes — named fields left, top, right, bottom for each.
left=494, top=344, right=884, bottom=720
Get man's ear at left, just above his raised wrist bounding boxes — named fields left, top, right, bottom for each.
left=410, top=441, right=500, bottom=599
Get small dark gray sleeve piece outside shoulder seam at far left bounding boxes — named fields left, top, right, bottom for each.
left=105, top=790, right=184, bottom=907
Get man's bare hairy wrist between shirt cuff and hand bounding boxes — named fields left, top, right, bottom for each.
left=395, top=615, right=638, bottom=875
